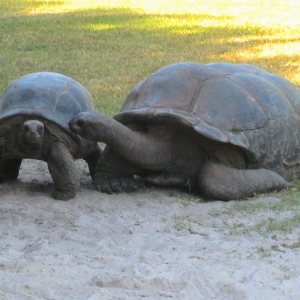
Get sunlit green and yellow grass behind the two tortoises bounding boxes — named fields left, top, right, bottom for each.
left=0, top=0, right=300, bottom=115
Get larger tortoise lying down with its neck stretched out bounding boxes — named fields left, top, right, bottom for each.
left=70, top=62, right=300, bottom=200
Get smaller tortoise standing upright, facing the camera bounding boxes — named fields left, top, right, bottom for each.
left=0, top=72, right=101, bottom=200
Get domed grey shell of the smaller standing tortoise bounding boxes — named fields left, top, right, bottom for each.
left=0, top=72, right=93, bottom=136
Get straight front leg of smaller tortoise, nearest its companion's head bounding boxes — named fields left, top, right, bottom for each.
left=47, top=142, right=80, bottom=200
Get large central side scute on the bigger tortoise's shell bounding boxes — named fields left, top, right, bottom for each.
left=194, top=77, right=268, bottom=131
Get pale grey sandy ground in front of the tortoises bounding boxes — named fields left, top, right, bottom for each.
left=0, top=160, right=300, bottom=300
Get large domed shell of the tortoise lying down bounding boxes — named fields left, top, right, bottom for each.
left=115, top=63, right=300, bottom=170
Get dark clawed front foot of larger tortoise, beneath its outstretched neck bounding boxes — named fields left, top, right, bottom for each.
left=94, top=146, right=141, bottom=194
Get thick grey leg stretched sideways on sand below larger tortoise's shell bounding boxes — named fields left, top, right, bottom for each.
left=198, top=161, right=288, bottom=200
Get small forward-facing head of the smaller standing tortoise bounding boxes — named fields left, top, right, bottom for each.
left=20, top=120, right=44, bottom=150
